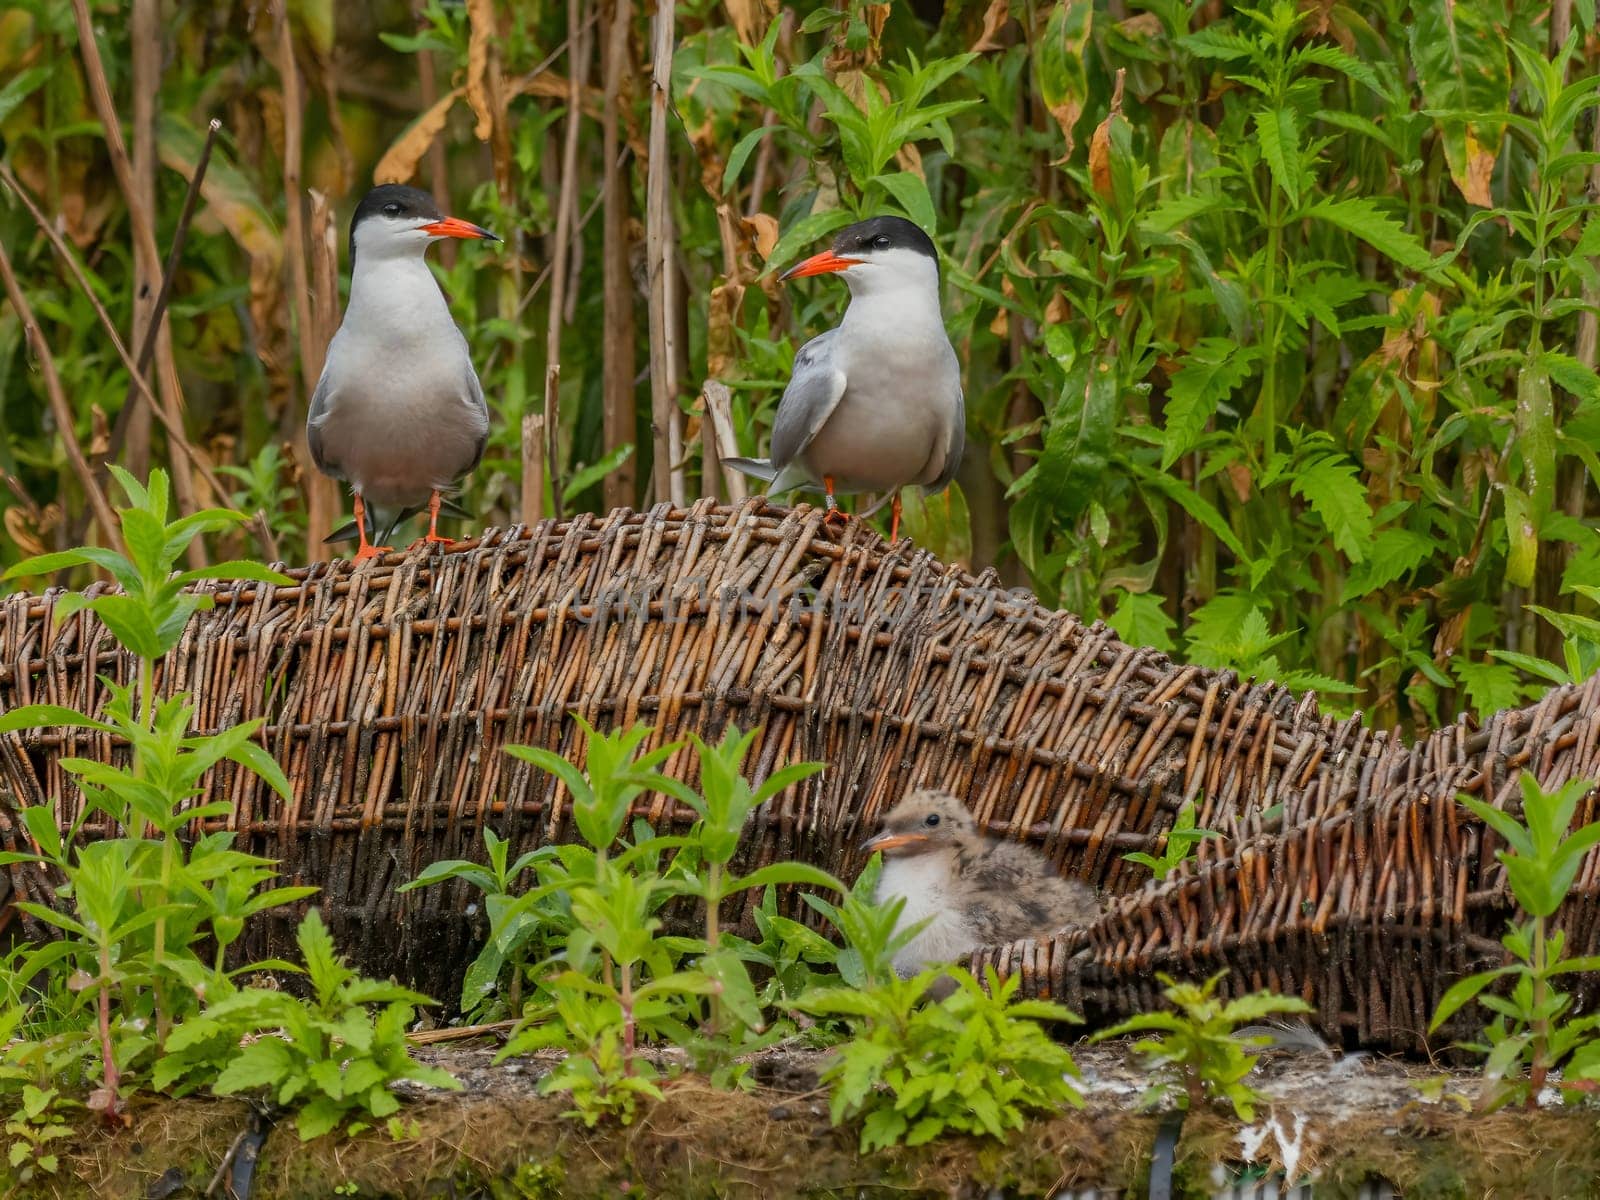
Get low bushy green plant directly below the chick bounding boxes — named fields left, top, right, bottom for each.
left=795, top=966, right=1083, bottom=1154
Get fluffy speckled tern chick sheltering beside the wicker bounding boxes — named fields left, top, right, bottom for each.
left=862, top=789, right=1099, bottom=976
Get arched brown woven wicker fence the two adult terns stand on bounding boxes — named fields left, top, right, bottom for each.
left=0, top=499, right=1600, bottom=1048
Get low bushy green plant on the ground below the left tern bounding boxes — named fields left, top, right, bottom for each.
left=154, top=909, right=461, bottom=1141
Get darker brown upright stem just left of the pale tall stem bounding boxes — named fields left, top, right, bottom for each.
left=600, top=0, right=638, bottom=509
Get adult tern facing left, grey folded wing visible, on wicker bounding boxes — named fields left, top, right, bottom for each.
left=723, top=216, right=966, bottom=541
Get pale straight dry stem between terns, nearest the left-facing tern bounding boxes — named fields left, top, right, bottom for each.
left=645, top=0, right=683, bottom=504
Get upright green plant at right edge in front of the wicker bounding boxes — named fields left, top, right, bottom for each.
left=1429, top=771, right=1600, bottom=1109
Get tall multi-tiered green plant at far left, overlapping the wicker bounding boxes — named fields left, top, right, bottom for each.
left=0, top=467, right=300, bottom=1118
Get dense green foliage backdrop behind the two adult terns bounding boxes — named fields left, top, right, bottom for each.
left=0, top=0, right=1600, bottom=730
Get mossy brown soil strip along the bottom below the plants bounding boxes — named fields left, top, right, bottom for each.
left=18, top=1040, right=1600, bottom=1200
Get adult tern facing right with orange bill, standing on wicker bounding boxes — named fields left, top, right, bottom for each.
left=306, top=184, right=499, bottom=560
